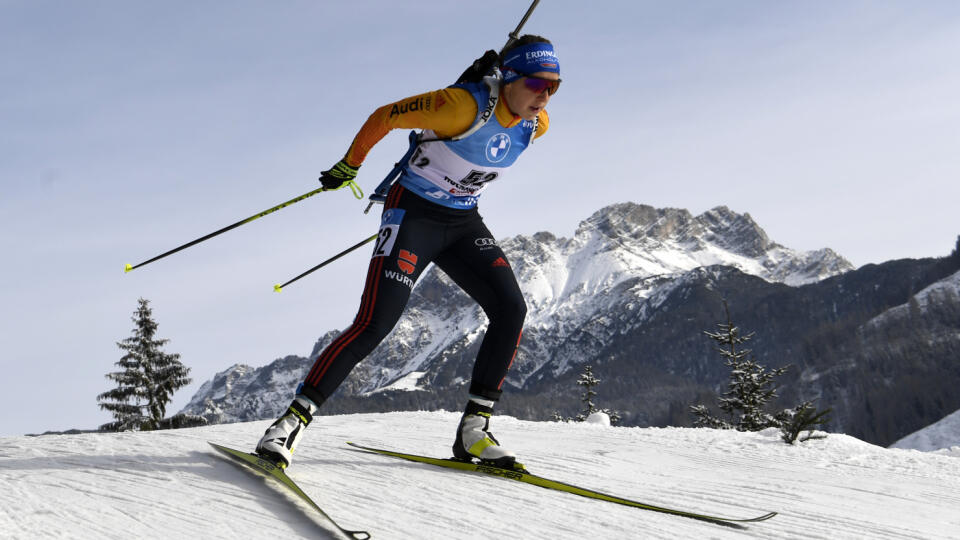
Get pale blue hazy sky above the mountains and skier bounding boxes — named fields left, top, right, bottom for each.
left=0, top=0, right=960, bottom=436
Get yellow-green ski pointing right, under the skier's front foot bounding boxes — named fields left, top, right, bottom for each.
left=347, top=442, right=777, bottom=527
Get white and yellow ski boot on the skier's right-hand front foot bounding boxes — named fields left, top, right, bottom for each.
left=453, top=398, right=526, bottom=472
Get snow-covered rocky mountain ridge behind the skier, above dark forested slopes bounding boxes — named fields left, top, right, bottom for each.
left=184, top=203, right=852, bottom=421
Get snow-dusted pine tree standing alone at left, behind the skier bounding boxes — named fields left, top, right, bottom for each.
left=97, top=298, right=197, bottom=431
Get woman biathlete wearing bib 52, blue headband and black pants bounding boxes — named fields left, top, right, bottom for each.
left=256, top=35, right=560, bottom=468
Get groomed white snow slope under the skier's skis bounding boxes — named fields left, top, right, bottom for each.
left=0, top=412, right=960, bottom=540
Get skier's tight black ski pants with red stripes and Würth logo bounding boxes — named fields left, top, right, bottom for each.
left=300, top=184, right=527, bottom=405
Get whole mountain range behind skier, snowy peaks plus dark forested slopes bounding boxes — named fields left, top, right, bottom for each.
left=184, top=203, right=960, bottom=444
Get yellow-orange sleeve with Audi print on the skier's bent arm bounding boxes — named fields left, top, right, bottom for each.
left=344, top=88, right=480, bottom=167
